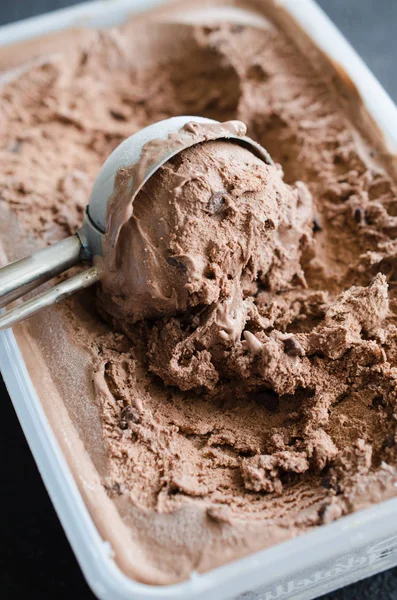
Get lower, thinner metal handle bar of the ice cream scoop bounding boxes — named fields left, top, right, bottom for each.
left=0, top=267, right=99, bottom=331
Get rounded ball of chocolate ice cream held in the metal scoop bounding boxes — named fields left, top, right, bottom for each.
left=97, top=140, right=311, bottom=322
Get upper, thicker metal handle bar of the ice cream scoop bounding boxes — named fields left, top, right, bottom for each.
left=0, top=234, right=85, bottom=308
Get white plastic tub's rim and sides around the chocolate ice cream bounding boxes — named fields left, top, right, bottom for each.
left=0, top=0, right=397, bottom=600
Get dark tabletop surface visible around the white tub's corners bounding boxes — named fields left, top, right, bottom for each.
left=0, top=0, right=397, bottom=600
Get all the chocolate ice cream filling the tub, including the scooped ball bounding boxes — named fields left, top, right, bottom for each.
left=0, top=1, right=397, bottom=583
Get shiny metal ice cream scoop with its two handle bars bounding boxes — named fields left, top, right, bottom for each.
left=0, top=117, right=272, bottom=331
